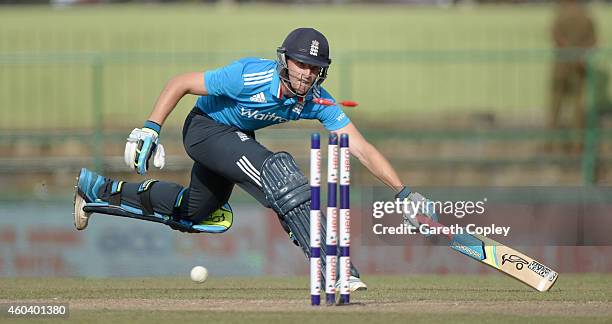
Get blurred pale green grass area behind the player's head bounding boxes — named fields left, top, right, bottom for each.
left=0, top=5, right=612, bottom=130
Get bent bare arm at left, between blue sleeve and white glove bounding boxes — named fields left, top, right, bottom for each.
left=149, top=72, right=208, bottom=125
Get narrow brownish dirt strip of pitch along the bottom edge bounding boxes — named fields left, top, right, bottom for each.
left=5, top=298, right=612, bottom=316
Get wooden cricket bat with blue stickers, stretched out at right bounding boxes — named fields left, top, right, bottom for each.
left=416, top=214, right=559, bottom=291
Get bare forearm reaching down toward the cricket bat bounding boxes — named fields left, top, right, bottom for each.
left=334, top=123, right=404, bottom=192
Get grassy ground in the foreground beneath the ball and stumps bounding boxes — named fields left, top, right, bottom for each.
left=0, top=274, right=612, bottom=323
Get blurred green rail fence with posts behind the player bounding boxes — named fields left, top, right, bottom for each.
left=0, top=49, right=612, bottom=184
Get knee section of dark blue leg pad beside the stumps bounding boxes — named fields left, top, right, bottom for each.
left=261, top=152, right=310, bottom=217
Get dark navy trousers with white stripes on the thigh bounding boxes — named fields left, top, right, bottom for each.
left=178, top=108, right=273, bottom=222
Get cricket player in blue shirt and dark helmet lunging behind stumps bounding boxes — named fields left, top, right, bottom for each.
left=74, top=28, right=437, bottom=291
